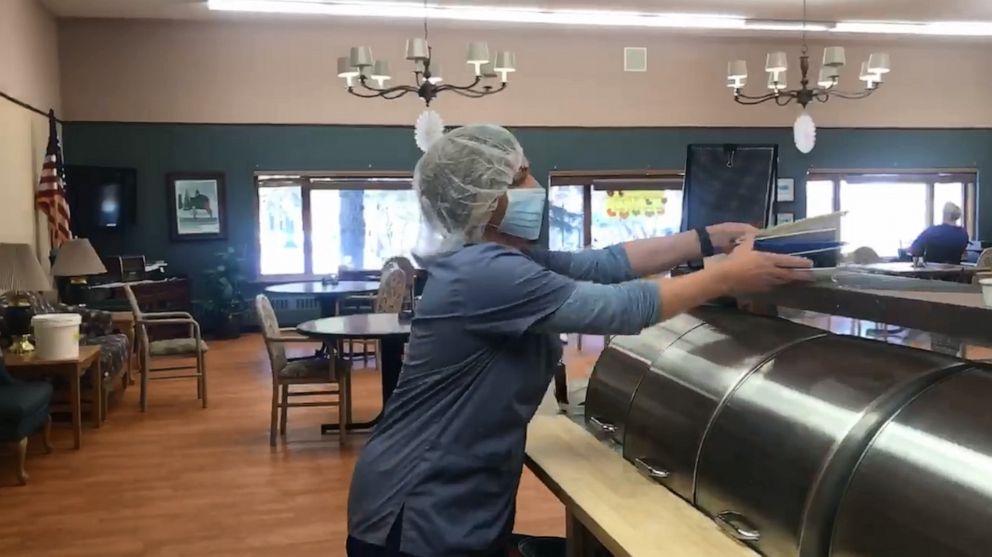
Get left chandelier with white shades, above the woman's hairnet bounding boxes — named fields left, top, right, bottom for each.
left=338, top=0, right=516, bottom=106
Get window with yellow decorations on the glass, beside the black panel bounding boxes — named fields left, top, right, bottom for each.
left=548, top=173, right=682, bottom=251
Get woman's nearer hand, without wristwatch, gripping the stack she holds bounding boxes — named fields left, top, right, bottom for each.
left=712, top=235, right=813, bottom=295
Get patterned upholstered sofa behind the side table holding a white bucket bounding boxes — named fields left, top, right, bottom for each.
left=0, top=292, right=132, bottom=391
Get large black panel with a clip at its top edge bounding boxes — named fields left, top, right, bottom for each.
left=682, top=144, right=778, bottom=230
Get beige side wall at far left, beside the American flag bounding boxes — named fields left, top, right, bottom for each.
left=0, top=0, right=61, bottom=249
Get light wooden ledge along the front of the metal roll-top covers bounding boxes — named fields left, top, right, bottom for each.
left=527, top=415, right=757, bottom=557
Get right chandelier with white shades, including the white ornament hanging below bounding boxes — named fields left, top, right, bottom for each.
left=727, top=0, right=891, bottom=153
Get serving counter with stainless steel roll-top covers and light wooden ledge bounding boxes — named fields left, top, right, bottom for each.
left=527, top=304, right=992, bottom=557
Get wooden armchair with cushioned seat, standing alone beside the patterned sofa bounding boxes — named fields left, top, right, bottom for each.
left=123, top=284, right=208, bottom=412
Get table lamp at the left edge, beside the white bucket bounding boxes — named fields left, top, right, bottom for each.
left=0, top=244, right=52, bottom=354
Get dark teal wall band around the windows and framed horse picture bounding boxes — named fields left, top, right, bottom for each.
left=63, top=123, right=992, bottom=288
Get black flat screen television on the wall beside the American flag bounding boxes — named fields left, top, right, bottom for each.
left=65, top=165, right=138, bottom=236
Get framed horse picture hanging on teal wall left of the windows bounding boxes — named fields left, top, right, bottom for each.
left=165, top=172, right=227, bottom=241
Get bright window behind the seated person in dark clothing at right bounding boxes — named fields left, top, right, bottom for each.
left=806, top=173, right=976, bottom=257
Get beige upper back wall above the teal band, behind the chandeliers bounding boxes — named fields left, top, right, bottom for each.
left=60, top=16, right=992, bottom=127
